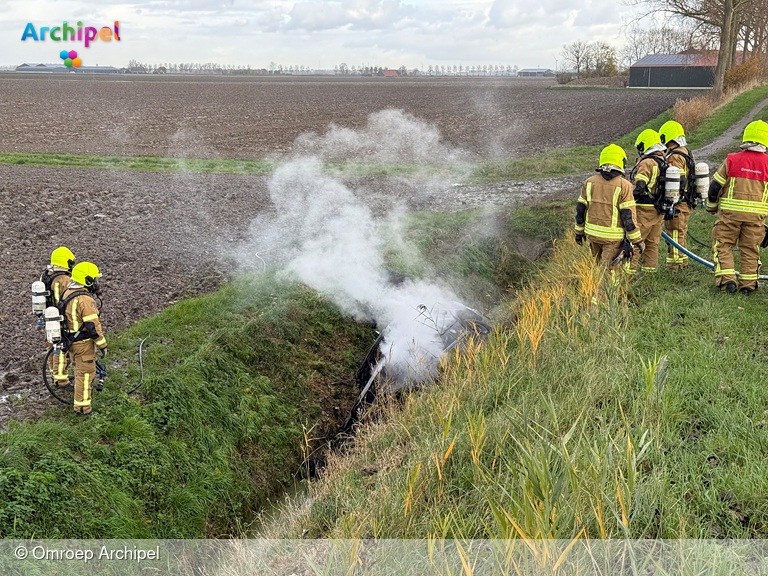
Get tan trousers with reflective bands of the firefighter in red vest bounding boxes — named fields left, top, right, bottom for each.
left=712, top=211, right=765, bottom=290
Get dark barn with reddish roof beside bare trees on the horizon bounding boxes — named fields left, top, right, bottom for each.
left=629, top=51, right=743, bottom=88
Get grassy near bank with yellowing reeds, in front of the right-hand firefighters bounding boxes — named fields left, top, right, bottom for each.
left=267, top=211, right=768, bottom=539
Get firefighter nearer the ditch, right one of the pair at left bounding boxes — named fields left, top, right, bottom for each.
left=62, top=262, right=107, bottom=416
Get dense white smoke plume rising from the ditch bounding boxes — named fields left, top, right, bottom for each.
left=236, top=110, right=476, bottom=382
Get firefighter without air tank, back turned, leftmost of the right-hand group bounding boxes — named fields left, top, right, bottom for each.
left=576, top=144, right=643, bottom=281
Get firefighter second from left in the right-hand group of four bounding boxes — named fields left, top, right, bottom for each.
left=628, top=129, right=666, bottom=274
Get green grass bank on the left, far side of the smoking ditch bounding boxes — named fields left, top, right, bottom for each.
left=0, top=205, right=571, bottom=538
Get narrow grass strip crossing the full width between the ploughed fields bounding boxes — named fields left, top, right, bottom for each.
left=6, top=86, right=768, bottom=182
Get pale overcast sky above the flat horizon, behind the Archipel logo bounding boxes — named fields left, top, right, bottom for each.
left=0, top=0, right=648, bottom=68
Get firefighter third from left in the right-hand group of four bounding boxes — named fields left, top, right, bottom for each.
left=659, top=120, right=696, bottom=270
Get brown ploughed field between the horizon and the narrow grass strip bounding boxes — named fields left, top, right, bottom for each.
left=0, top=73, right=691, bottom=160
